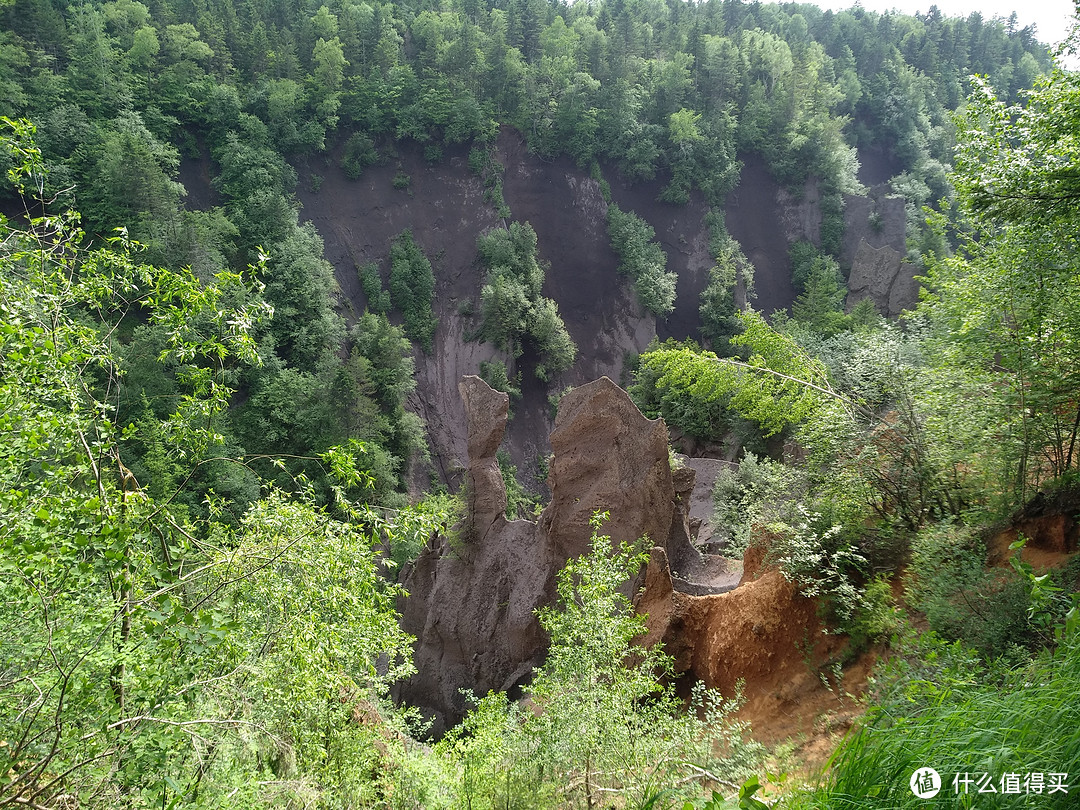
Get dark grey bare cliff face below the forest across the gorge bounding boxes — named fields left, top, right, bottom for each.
left=287, top=129, right=903, bottom=489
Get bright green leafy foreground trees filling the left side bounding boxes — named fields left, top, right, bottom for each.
left=0, top=126, right=438, bottom=808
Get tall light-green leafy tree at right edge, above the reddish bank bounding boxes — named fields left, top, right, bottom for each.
left=920, top=68, right=1080, bottom=508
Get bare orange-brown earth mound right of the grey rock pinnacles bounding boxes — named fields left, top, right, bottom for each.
left=637, top=546, right=875, bottom=774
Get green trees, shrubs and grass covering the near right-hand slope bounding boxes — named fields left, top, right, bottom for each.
left=634, top=42, right=1080, bottom=808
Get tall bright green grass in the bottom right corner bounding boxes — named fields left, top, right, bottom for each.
left=785, top=633, right=1080, bottom=810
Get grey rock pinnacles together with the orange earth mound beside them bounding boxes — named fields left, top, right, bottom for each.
left=395, top=377, right=843, bottom=734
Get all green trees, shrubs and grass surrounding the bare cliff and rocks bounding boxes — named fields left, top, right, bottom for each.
left=0, top=0, right=1080, bottom=809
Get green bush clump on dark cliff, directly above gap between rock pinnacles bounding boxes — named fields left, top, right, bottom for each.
left=476, top=222, right=578, bottom=382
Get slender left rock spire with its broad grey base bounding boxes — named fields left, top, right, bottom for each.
left=395, top=377, right=552, bottom=734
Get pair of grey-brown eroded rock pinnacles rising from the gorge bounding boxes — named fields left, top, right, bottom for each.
left=396, top=377, right=697, bottom=733
